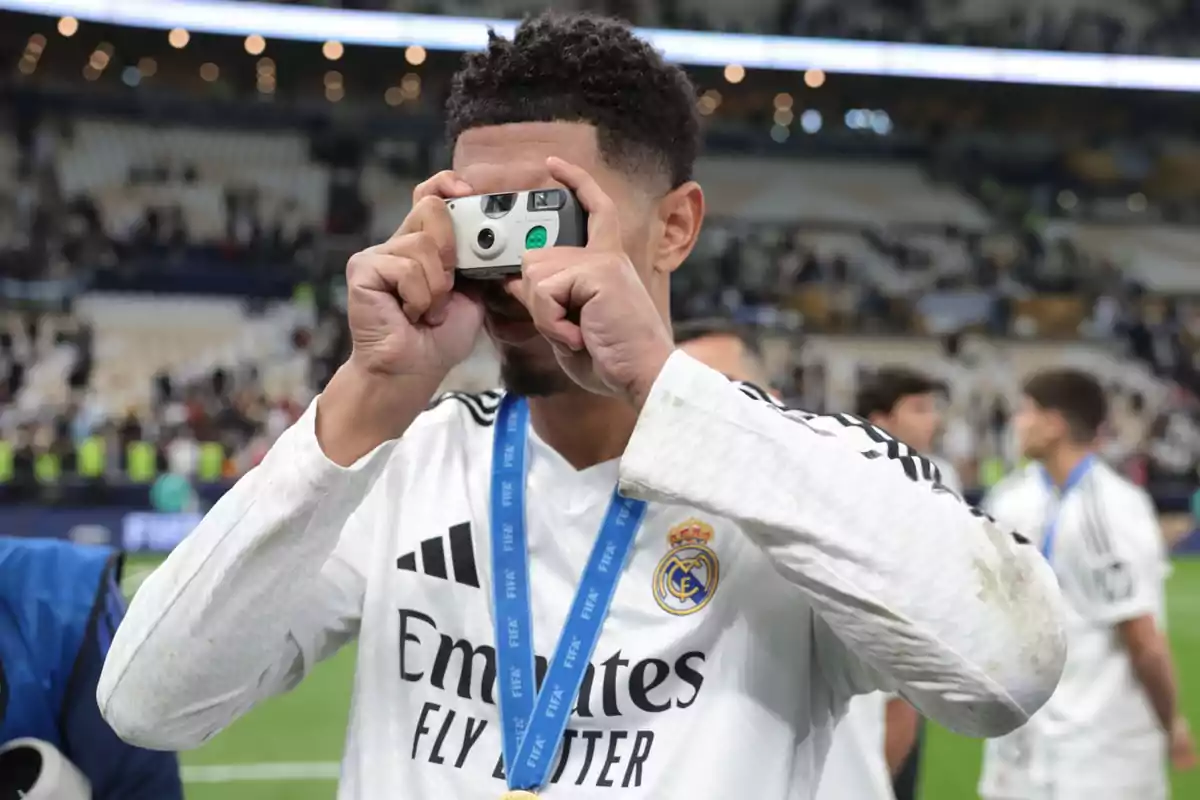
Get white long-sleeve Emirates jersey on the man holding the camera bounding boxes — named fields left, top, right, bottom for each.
left=98, top=353, right=1064, bottom=800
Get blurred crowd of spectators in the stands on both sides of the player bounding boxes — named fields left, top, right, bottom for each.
left=0, top=95, right=1200, bottom=498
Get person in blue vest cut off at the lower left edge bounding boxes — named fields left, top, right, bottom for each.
left=0, top=536, right=184, bottom=800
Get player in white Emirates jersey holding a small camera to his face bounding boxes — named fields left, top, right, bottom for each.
left=100, top=14, right=1066, bottom=800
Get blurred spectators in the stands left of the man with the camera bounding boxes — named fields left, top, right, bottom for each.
left=0, top=121, right=348, bottom=499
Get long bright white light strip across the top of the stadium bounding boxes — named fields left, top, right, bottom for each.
left=7, top=0, right=1200, bottom=92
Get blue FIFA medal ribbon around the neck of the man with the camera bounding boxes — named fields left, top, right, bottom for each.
left=491, top=395, right=646, bottom=792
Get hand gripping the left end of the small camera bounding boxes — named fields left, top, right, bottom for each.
left=346, top=170, right=484, bottom=379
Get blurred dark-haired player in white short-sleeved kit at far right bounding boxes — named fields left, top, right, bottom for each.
left=979, top=369, right=1195, bottom=800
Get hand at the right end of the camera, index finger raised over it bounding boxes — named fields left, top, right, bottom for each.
left=514, top=158, right=674, bottom=409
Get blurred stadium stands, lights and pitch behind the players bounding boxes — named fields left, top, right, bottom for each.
left=0, top=0, right=1200, bottom=800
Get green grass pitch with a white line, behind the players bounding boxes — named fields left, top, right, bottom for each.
left=119, top=559, right=1200, bottom=800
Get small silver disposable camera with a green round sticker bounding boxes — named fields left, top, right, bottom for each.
left=446, top=188, right=588, bottom=278
